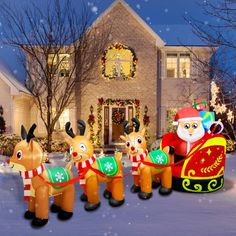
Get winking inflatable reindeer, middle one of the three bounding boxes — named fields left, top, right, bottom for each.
left=65, top=120, right=124, bottom=211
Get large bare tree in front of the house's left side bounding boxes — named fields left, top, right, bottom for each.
left=0, top=0, right=110, bottom=152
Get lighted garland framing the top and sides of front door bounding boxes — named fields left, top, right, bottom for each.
left=96, top=98, right=140, bottom=147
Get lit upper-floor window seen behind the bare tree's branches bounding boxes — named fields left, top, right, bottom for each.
left=48, top=53, right=70, bottom=77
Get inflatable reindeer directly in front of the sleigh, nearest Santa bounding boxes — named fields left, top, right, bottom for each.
left=120, top=118, right=173, bottom=199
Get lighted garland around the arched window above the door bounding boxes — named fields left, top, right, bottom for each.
left=101, top=43, right=138, bottom=80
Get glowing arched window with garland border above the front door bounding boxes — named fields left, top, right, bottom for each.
left=102, top=43, right=137, bottom=80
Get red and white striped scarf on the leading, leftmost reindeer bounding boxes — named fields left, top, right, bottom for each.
left=20, top=164, right=45, bottom=201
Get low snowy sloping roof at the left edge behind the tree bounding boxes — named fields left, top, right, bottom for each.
left=0, top=64, right=31, bottom=95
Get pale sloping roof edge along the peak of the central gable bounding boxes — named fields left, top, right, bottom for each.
left=91, top=0, right=165, bottom=46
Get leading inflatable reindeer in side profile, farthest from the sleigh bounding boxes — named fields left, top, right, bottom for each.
left=8, top=124, right=74, bottom=227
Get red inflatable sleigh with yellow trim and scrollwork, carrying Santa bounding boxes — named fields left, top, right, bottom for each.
left=161, top=133, right=226, bottom=193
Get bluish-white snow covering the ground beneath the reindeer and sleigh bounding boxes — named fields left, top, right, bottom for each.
left=0, top=153, right=236, bottom=236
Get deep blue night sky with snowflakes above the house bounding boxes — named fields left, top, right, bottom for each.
left=0, top=0, right=215, bottom=81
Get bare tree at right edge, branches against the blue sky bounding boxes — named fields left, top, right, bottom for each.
left=186, top=0, right=236, bottom=140
